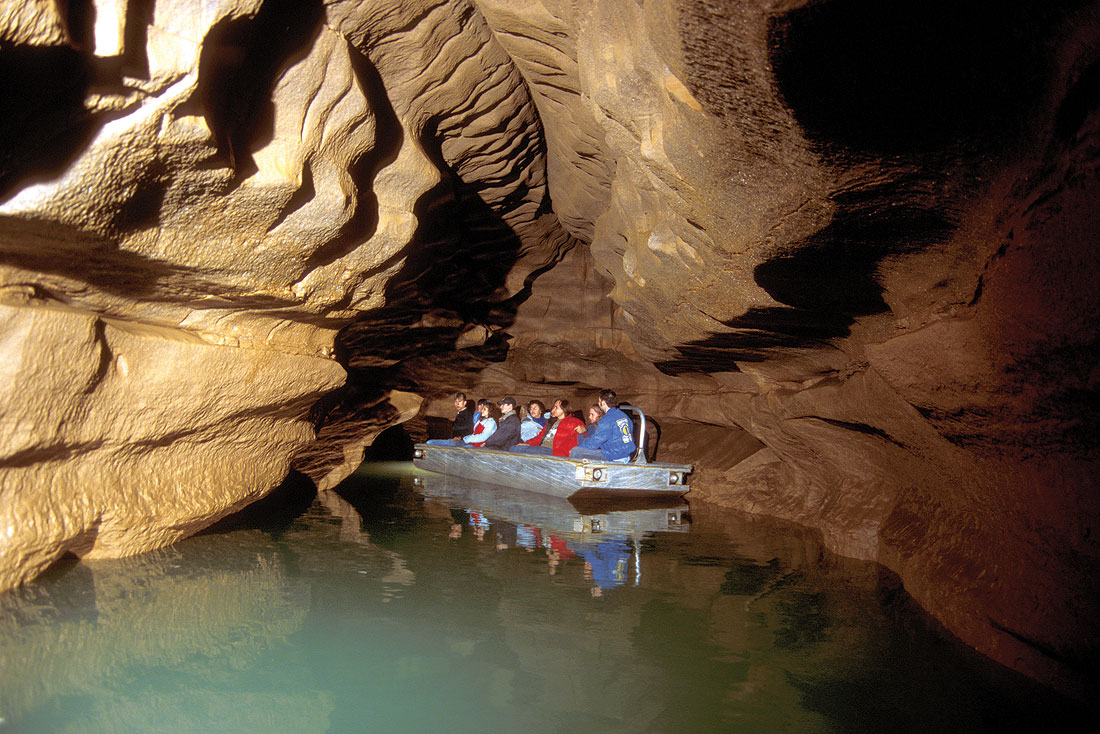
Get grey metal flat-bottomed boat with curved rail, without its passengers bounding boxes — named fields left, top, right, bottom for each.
left=413, top=405, right=692, bottom=497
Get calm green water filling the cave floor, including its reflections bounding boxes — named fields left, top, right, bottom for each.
left=0, top=464, right=1082, bottom=734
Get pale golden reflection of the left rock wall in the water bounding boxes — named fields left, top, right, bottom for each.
left=0, top=537, right=331, bottom=732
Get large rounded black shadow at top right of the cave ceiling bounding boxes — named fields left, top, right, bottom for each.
left=768, top=0, right=1056, bottom=155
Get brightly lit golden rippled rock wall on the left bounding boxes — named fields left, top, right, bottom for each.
left=0, top=0, right=571, bottom=588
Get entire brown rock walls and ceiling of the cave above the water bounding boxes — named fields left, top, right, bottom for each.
left=0, top=0, right=1100, bottom=692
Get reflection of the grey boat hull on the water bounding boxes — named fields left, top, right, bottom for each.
left=414, top=473, right=689, bottom=537
